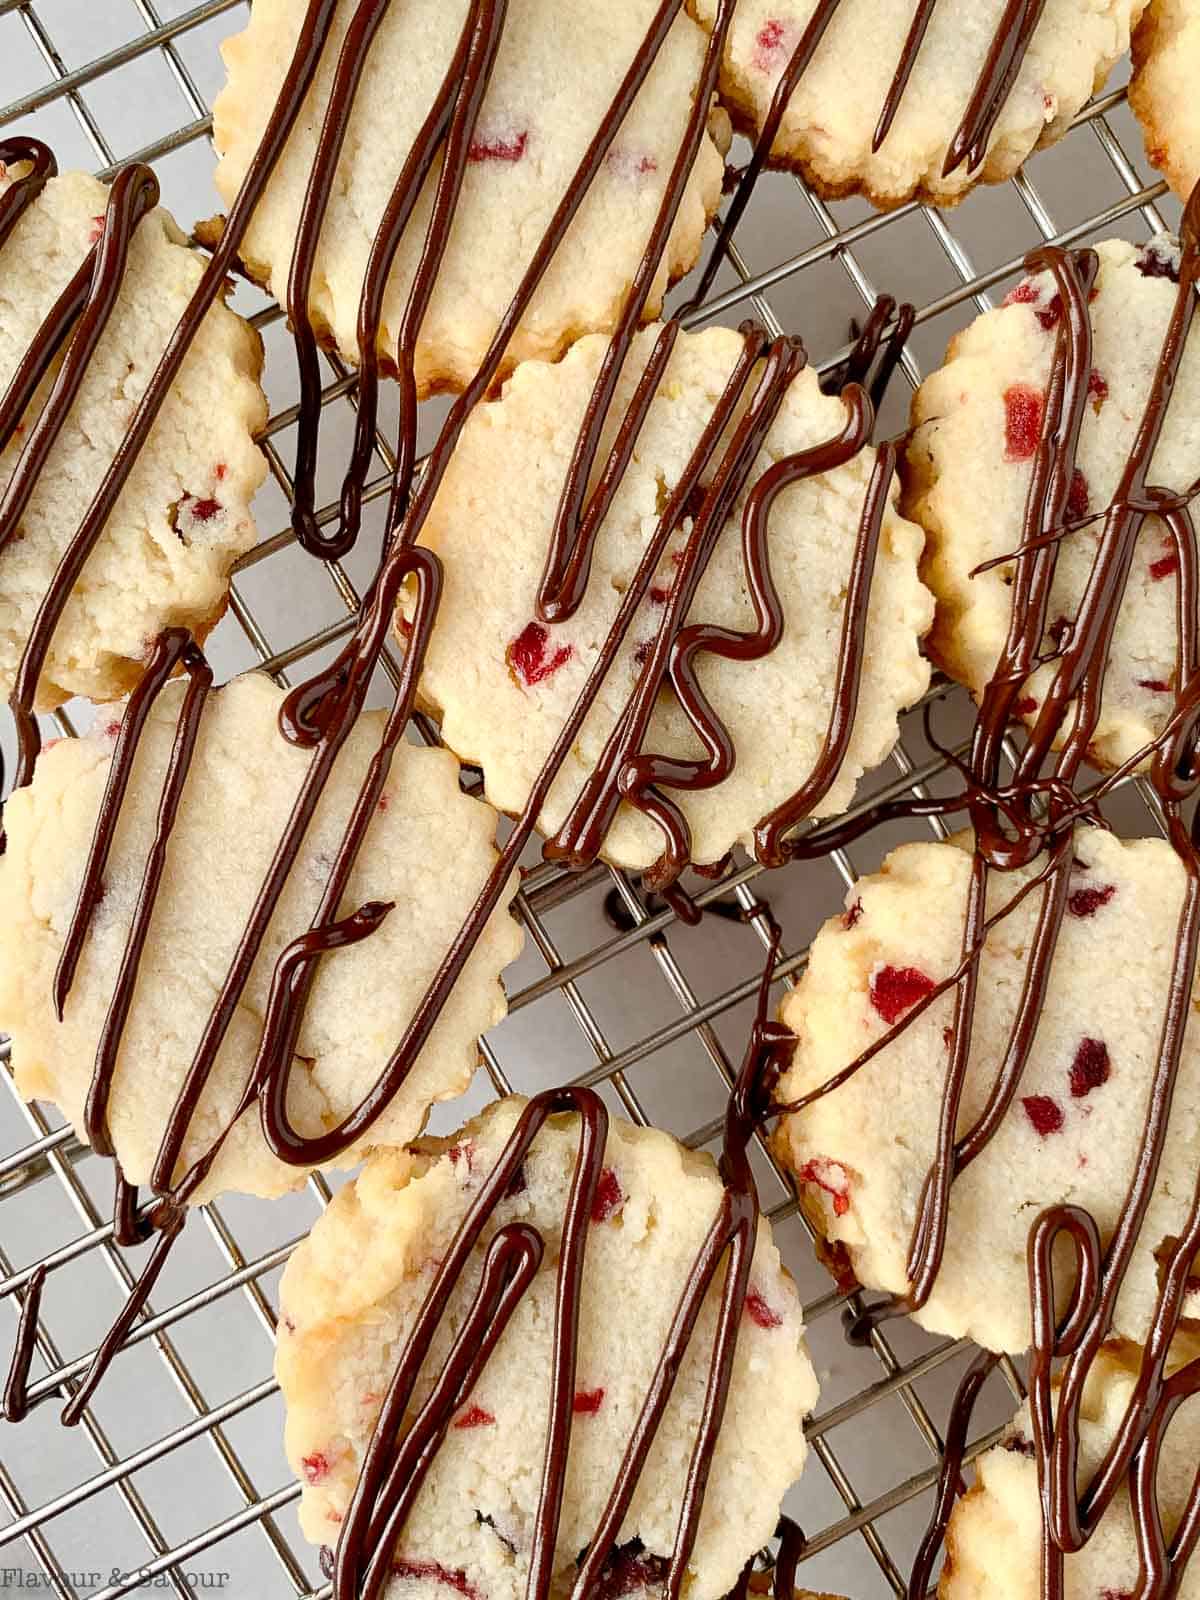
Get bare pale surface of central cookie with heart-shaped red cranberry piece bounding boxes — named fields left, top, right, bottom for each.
left=400, top=328, right=931, bottom=870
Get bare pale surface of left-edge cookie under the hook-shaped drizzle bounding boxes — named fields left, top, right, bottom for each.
left=0, top=675, right=522, bottom=1200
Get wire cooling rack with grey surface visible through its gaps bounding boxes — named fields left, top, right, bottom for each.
left=0, top=0, right=1178, bottom=1600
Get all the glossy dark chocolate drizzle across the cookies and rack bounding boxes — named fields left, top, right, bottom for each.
left=0, top=12, right=1177, bottom=1600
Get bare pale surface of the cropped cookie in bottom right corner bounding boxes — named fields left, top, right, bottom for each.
left=938, top=1344, right=1200, bottom=1600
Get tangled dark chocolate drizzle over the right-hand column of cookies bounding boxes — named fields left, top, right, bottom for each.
left=776, top=189, right=1200, bottom=1600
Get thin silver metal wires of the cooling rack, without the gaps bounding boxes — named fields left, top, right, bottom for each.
left=0, top=0, right=1184, bottom=1600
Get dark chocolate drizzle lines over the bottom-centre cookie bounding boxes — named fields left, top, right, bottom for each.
left=333, top=926, right=798, bottom=1600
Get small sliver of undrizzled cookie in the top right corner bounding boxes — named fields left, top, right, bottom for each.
left=1130, top=0, right=1200, bottom=200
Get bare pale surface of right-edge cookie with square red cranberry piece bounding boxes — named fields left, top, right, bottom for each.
left=904, top=238, right=1200, bottom=766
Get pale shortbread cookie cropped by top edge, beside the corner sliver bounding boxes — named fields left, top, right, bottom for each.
left=690, top=0, right=1144, bottom=206
